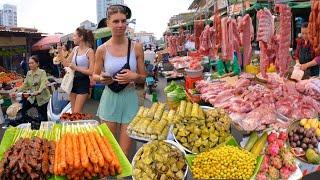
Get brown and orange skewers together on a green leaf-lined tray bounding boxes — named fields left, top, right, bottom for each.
left=0, top=121, right=132, bottom=179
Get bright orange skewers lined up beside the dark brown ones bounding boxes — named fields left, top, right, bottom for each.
left=54, top=125, right=121, bottom=179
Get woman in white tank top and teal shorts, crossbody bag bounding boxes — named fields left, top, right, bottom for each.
left=93, top=5, right=146, bottom=156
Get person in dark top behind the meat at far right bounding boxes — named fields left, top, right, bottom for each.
left=294, top=23, right=319, bottom=76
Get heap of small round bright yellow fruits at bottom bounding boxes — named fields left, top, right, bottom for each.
left=191, top=145, right=256, bottom=179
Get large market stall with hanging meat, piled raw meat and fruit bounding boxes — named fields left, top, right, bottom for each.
left=128, top=2, right=320, bottom=179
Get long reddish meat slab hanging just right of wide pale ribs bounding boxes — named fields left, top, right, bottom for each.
left=276, top=4, right=292, bottom=77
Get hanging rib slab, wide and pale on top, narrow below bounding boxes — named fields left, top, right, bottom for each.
left=257, top=8, right=274, bottom=78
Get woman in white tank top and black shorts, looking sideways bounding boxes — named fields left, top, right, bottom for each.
left=59, top=28, right=94, bottom=113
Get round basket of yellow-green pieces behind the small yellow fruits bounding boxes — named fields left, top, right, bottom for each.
left=173, top=105, right=231, bottom=154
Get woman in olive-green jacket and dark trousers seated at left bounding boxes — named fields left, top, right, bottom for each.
left=13, top=56, right=50, bottom=121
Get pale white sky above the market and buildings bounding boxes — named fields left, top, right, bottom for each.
left=0, top=0, right=193, bottom=38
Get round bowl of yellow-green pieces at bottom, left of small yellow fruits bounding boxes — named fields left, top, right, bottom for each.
left=132, top=141, right=187, bottom=180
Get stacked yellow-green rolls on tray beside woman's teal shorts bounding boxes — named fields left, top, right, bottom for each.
left=127, top=103, right=176, bottom=140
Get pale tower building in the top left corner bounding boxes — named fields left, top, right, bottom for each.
left=0, top=4, right=18, bottom=27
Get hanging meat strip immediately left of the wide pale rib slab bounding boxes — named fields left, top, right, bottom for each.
left=238, top=14, right=254, bottom=66
